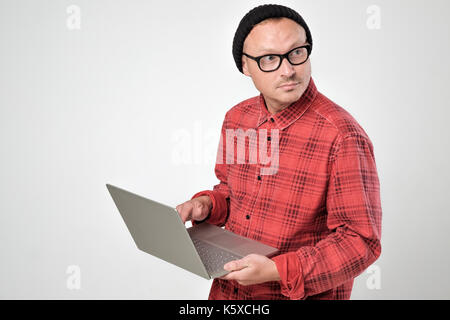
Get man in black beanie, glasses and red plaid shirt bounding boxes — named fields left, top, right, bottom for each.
left=177, top=5, right=381, bottom=299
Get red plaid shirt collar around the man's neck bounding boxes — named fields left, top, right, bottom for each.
left=256, top=77, right=318, bottom=130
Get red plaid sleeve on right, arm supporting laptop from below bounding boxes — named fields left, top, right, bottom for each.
left=272, top=135, right=382, bottom=299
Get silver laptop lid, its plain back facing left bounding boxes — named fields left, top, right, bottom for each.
left=106, top=184, right=211, bottom=279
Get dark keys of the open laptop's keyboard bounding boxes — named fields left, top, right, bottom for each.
left=192, top=239, right=242, bottom=276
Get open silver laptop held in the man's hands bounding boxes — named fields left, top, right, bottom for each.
left=106, top=184, right=278, bottom=279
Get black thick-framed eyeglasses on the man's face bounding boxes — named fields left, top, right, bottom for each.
left=242, top=44, right=311, bottom=72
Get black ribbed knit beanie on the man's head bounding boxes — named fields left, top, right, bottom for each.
left=233, top=4, right=312, bottom=73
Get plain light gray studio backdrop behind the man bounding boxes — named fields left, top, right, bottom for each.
left=0, top=0, right=450, bottom=299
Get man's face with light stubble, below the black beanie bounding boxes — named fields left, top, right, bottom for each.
left=242, top=18, right=311, bottom=112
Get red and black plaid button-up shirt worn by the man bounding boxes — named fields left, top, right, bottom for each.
left=192, top=78, right=381, bottom=299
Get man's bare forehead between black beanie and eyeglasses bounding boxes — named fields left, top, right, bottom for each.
left=244, top=18, right=306, bottom=55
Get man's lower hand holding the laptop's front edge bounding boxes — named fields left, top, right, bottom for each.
left=220, top=254, right=281, bottom=286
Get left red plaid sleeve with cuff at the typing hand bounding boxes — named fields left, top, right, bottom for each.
left=191, top=116, right=230, bottom=226
